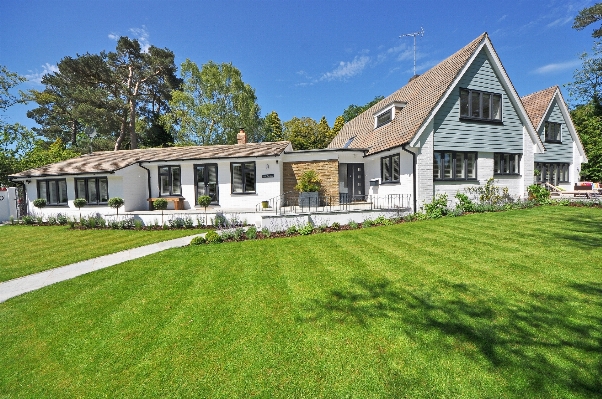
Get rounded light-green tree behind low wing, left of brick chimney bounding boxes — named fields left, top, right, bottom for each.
left=162, top=59, right=264, bottom=145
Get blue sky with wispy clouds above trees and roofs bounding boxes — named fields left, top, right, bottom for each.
left=0, top=0, right=595, bottom=131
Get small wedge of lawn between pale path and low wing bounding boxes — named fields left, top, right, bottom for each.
left=0, top=225, right=202, bottom=282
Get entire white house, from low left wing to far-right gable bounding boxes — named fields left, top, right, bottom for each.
left=11, top=33, right=585, bottom=225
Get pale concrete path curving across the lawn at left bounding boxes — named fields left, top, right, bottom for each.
left=0, top=233, right=205, bottom=302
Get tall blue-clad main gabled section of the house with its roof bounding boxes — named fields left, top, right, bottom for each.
left=329, top=33, right=545, bottom=210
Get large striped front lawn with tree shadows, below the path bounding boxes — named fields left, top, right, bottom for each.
left=0, top=207, right=602, bottom=398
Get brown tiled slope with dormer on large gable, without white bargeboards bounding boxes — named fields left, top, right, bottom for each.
left=328, top=33, right=487, bottom=155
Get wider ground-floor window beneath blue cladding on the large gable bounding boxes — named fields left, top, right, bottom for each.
left=433, top=151, right=477, bottom=180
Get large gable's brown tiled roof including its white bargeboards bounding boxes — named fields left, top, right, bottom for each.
left=328, top=32, right=543, bottom=155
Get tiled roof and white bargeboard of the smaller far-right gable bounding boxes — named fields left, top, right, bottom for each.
left=521, top=86, right=587, bottom=162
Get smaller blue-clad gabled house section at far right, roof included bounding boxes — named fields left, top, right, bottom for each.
left=522, top=86, right=587, bottom=189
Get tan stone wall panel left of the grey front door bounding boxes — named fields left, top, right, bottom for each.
left=282, top=159, right=339, bottom=202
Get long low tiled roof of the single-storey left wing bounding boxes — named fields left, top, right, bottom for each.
left=10, top=141, right=290, bottom=178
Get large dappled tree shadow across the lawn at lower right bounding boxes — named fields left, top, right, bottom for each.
left=304, top=278, right=602, bottom=397
